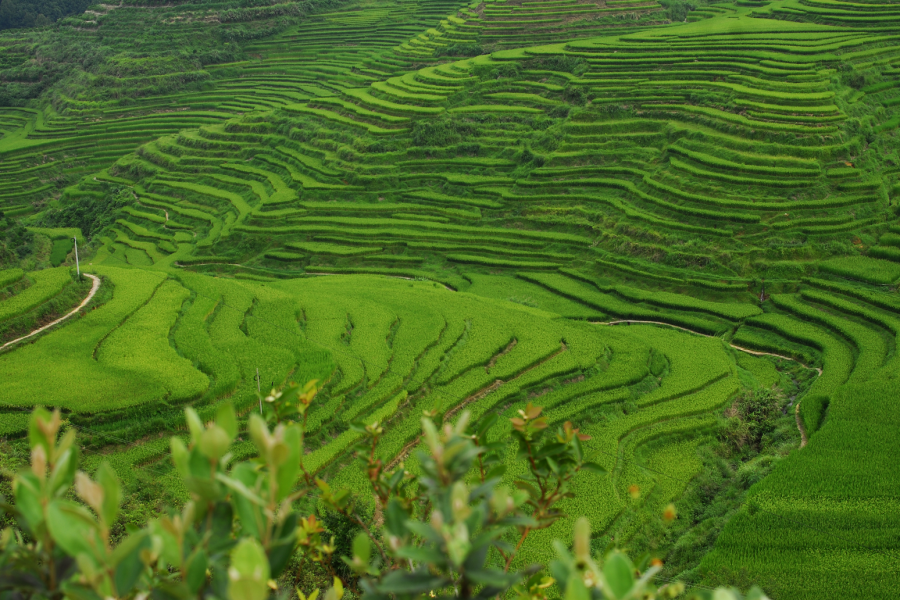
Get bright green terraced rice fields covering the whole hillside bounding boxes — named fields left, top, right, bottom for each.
left=0, top=0, right=900, bottom=599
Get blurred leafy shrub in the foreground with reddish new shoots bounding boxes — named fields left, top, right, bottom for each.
left=0, top=383, right=764, bottom=600
